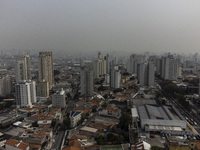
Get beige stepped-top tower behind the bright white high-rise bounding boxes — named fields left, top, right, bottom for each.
left=15, top=55, right=31, bottom=83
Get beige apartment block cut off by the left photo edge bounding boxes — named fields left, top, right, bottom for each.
left=0, top=75, right=13, bottom=96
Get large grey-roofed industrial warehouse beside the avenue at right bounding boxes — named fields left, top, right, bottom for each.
left=133, top=104, right=187, bottom=135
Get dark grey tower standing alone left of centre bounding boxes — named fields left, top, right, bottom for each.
left=80, top=66, right=94, bottom=96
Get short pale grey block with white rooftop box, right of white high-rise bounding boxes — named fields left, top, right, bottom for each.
left=52, top=89, right=66, bottom=108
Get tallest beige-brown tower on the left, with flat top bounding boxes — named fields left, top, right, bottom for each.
left=38, top=52, right=54, bottom=89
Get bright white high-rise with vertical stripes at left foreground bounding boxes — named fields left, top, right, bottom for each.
left=15, top=81, right=36, bottom=108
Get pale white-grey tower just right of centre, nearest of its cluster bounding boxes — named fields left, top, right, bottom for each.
left=110, top=65, right=121, bottom=89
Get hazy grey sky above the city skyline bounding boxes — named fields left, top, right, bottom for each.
left=0, top=0, right=200, bottom=53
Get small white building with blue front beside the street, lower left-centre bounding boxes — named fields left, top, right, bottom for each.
left=70, top=111, right=83, bottom=128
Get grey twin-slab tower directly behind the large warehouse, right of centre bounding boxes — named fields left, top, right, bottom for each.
left=137, top=62, right=155, bottom=86
